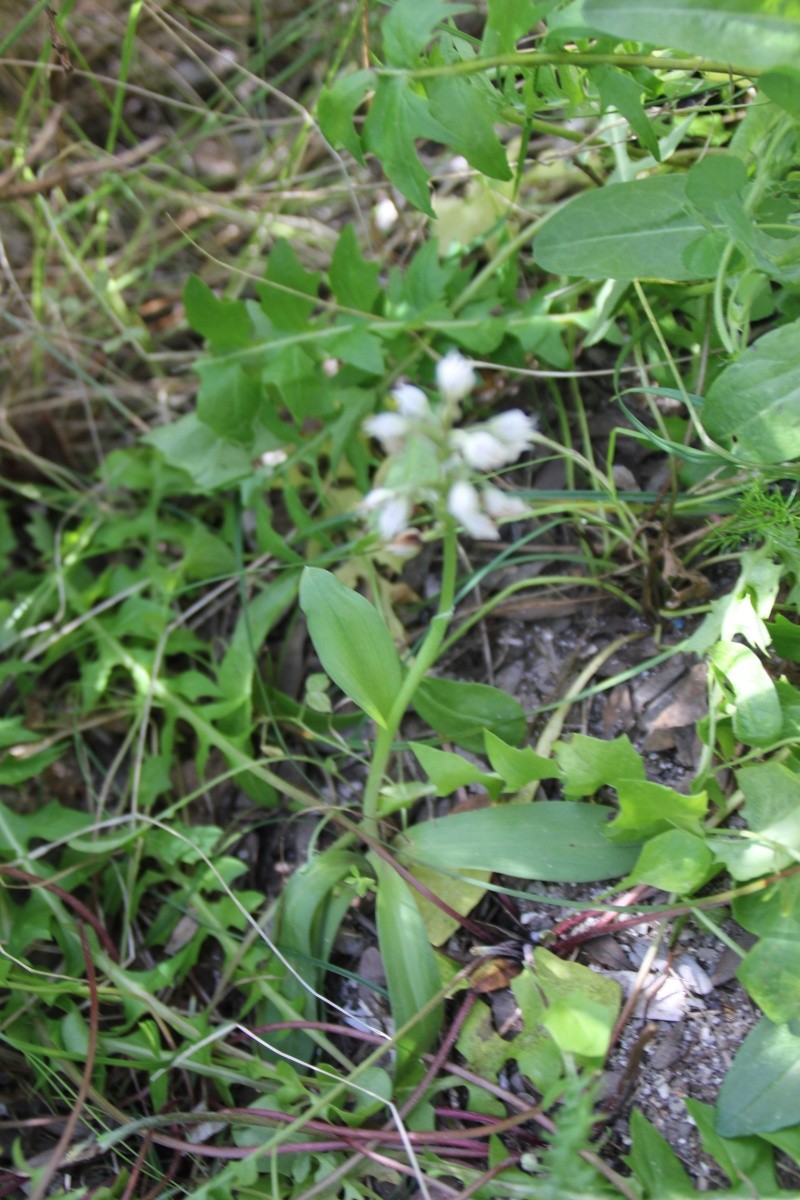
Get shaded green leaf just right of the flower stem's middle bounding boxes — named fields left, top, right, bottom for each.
left=413, top=678, right=528, bottom=754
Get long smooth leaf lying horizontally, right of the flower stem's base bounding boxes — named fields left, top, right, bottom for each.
left=397, top=800, right=637, bottom=883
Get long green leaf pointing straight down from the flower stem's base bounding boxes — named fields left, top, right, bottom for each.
left=374, top=858, right=443, bottom=1076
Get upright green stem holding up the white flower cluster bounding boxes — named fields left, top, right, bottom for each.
left=361, top=517, right=458, bottom=838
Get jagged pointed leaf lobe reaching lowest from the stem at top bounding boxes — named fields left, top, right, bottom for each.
left=363, top=76, right=450, bottom=217
